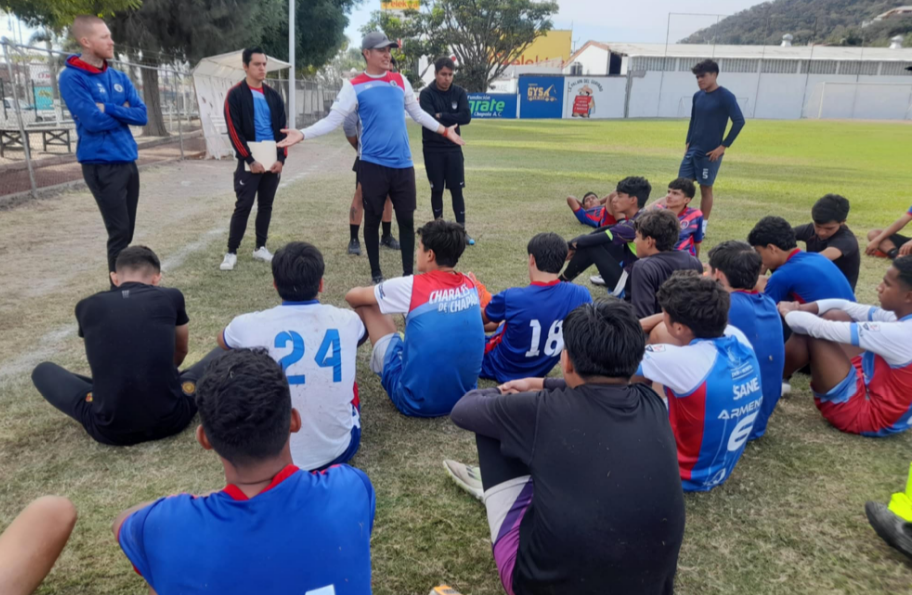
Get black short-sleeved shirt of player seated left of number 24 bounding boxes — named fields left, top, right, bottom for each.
left=76, top=283, right=191, bottom=444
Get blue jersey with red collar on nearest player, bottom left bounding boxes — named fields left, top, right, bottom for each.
left=117, top=465, right=375, bottom=595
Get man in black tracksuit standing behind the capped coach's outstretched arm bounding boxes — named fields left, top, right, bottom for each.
left=418, top=58, right=475, bottom=246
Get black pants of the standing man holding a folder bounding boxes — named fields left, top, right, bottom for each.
left=228, top=159, right=282, bottom=254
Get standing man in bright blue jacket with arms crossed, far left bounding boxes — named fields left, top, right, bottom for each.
left=60, top=15, right=147, bottom=287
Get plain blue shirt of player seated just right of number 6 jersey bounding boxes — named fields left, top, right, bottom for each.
left=728, top=290, right=785, bottom=440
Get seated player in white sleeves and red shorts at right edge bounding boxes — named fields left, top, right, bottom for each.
left=779, top=256, right=912, bottom=436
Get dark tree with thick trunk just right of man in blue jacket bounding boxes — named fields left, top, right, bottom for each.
left=108, top=0, right=283, bottom=136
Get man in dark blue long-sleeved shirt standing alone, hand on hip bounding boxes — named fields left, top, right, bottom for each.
left=678, top=60, right=744, bottom=234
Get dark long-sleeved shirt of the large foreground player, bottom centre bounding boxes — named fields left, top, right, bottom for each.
left=451, top=378, right=684, bottom=595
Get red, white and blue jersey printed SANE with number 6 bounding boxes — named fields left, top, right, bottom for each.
left=637, top=326, right=763, bottom=492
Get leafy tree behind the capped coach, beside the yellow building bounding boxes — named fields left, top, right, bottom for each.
left=364, top=0, right=558, bottom=92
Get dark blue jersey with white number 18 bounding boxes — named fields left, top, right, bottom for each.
left=481, top=281, right=592, bottom=383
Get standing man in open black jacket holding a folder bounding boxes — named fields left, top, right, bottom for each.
left=219, top=48, right=288, bottom=271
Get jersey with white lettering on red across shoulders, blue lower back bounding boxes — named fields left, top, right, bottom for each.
left=374, top=271, right=485, bottom=417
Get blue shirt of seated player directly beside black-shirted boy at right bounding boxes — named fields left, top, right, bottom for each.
left=764, top=248, right=855, bottom=304
